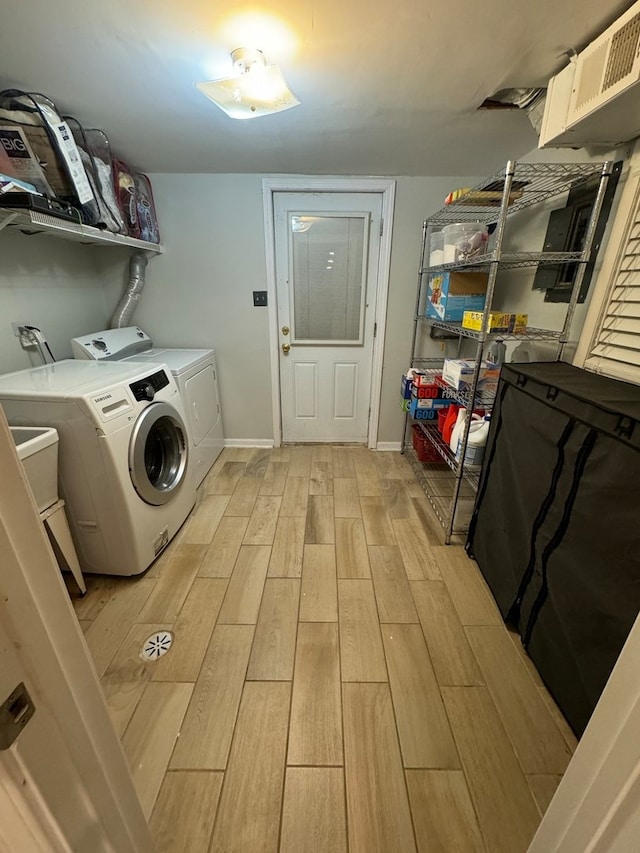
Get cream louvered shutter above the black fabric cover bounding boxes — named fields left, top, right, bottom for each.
left=584, top=186, right=640, bottom=384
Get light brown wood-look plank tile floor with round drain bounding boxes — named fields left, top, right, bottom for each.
left=67, top=446, right=576, bottom=853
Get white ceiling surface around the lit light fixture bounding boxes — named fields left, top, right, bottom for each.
left=0, top=0, right=630, bottom=175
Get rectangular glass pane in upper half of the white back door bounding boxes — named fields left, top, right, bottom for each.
left=290, top=213, right=369, bottom=346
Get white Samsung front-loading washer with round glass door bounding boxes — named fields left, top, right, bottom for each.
left=0, top=359, right=195, bottom=575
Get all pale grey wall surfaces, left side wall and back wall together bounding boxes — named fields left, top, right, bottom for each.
left=0, top=152, right=624, bottom=442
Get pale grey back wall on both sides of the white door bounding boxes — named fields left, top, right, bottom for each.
left=108, top=175, right=476, bottom=441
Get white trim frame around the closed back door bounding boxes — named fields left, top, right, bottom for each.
left=262, top=176, right=396, bottom=450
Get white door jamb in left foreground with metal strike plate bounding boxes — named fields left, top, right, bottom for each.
left=0, top=407, right=153, bottom=853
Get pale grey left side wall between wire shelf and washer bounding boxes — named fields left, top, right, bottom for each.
left=0, top=228, right=109, bottom=373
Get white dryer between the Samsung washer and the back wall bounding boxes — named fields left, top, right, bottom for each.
left=71, top=326, right=224, bottom=487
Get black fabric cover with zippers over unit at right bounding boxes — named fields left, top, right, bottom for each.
left=467, top=362, right=640, bottom=735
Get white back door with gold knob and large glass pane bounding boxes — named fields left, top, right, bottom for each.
left=274, top=192, right=382, bottom=443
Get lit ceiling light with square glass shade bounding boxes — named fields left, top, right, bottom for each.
left=196, top=47, right=300, bottom=119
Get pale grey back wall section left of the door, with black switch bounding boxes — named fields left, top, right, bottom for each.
left=119, top=175, right=272, bottom=439
